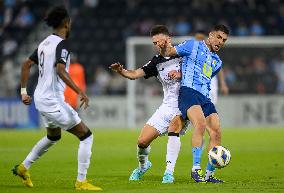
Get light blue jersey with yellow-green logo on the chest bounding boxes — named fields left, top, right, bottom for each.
left=175, top=39, right=222, bottom=98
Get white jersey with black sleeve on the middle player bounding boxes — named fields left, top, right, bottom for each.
left=142, top=55, right=181, bottom=107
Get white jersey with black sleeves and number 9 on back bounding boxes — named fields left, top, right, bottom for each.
left=30, top=34, right=70, bottom=112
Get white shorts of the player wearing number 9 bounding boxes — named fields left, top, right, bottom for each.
left=37, top=102, right=81, bottom=130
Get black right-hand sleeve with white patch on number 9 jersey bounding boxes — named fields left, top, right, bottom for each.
left=55, top=40, right=70, bottom=65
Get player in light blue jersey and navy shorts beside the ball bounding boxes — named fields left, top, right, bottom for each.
left=166, top=25, right=229, bottom=183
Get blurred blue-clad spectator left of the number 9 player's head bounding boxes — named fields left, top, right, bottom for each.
left=15, top=6, right=34, bottom=28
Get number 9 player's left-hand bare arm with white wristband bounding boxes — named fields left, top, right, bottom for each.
left=21, top=59, right=34, bottom=105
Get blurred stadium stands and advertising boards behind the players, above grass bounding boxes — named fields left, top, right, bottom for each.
left=0, top=0, right=284, bottom=128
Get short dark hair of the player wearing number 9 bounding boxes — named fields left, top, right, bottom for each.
left=44, top=6, right=70, bottom=29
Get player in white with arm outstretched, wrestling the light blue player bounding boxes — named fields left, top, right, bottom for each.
left=110, top=25, right=186, bottom=183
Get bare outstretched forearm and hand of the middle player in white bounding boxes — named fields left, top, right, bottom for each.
left=109, top=62, right=145, bottom=80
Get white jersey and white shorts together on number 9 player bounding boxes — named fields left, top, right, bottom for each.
left=30, top=34, right=81, bottom=130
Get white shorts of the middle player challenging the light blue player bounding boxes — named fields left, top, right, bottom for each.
left=146, top=104, right=189, bottom=135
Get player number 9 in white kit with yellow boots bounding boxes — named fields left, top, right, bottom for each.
left=12, top=7, right=102, bottom=191
